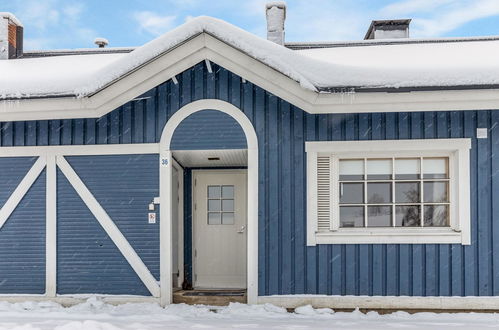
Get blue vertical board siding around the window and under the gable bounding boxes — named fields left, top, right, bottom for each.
left=0, top=63, right=499, bottom=296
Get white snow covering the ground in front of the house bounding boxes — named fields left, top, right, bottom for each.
left=0, top=298, right=499, bottom=330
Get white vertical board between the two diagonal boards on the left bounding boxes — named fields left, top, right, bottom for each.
left=45, top=155, right=57, bottom=297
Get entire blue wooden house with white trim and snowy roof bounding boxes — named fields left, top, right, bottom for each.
left=0, top=2, right=499, bottom=310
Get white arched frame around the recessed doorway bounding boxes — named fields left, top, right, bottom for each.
left=159, top=99, right=258, bottom=306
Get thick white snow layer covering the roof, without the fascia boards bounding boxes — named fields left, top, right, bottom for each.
left=0, top=17, right=499, bottom=99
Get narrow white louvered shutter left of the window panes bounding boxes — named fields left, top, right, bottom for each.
left=317, top=156, right=332, bottom=231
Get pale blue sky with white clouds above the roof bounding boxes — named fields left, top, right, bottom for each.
left=0, top=0, right=499, bottom=50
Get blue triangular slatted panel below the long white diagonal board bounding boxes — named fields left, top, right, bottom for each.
left=57, top=170, right=150, bottom=296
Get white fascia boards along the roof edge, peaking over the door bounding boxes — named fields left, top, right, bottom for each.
left=0, top=33, right=499, bottom=121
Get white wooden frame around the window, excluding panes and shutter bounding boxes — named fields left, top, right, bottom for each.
left=305, top=138, right=471, bottom=246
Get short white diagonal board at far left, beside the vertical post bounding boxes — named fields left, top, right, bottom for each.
left=0, top=156, right=47, bottom=229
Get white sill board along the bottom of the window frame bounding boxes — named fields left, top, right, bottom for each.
left=315, top=228, right=470, bottom=245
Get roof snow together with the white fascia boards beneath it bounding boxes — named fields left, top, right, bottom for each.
left=0, top=17, right=499, bottom=120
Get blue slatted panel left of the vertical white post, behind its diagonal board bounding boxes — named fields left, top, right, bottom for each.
left=0, top=164, right=45, bottom=294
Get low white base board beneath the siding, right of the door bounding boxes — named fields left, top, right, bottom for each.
left=258, top=295, right=499, bottom=311
